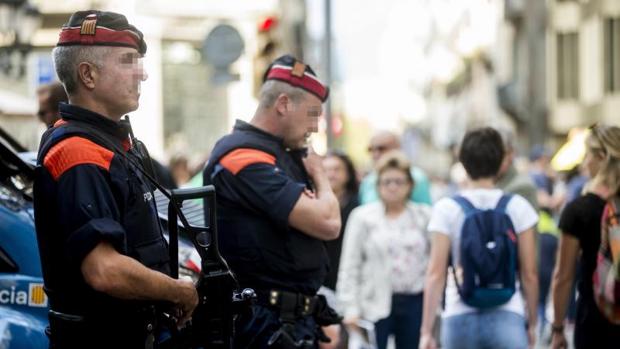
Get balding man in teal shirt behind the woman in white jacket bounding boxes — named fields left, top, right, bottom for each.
left=359, top=131, right=432, bottom=205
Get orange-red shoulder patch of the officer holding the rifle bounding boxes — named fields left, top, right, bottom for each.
left=43, top=136, right=114, bottom=180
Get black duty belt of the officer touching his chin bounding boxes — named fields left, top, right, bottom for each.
left=256, top=290, right=319, bottom=316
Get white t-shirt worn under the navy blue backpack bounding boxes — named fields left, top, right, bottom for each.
left=428, top=189, right=538, bottom=317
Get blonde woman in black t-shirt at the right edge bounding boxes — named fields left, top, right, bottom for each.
left=551, top=125, right=620, bottom=349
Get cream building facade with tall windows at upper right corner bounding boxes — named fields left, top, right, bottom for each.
left=547, top=0, right=620, bottom=134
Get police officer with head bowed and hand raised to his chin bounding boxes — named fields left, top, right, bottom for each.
left=203, top=55, right=341, bottom=348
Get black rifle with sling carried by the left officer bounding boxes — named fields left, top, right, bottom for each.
left=42, top=117, right=256, bottom=349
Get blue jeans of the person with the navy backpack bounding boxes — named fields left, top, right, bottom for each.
left=441, top=310, right=528, bottom=349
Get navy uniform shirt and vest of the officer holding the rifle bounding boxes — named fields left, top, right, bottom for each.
left=34, top=104, right=170, bottom=315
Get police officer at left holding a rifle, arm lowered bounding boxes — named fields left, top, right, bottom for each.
left=34, top=11, right=198, bottom=348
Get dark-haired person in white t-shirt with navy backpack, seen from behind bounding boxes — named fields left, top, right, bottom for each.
left=419, top=127, right=538, bottom=349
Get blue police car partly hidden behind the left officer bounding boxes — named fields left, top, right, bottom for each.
left=0, top=128, right=202, bottom=349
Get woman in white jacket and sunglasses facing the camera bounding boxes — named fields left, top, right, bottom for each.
left=336, top=151, right=431, bottom=349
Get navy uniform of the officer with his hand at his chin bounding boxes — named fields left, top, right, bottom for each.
left=203, top=121, right=328, bottom=348
